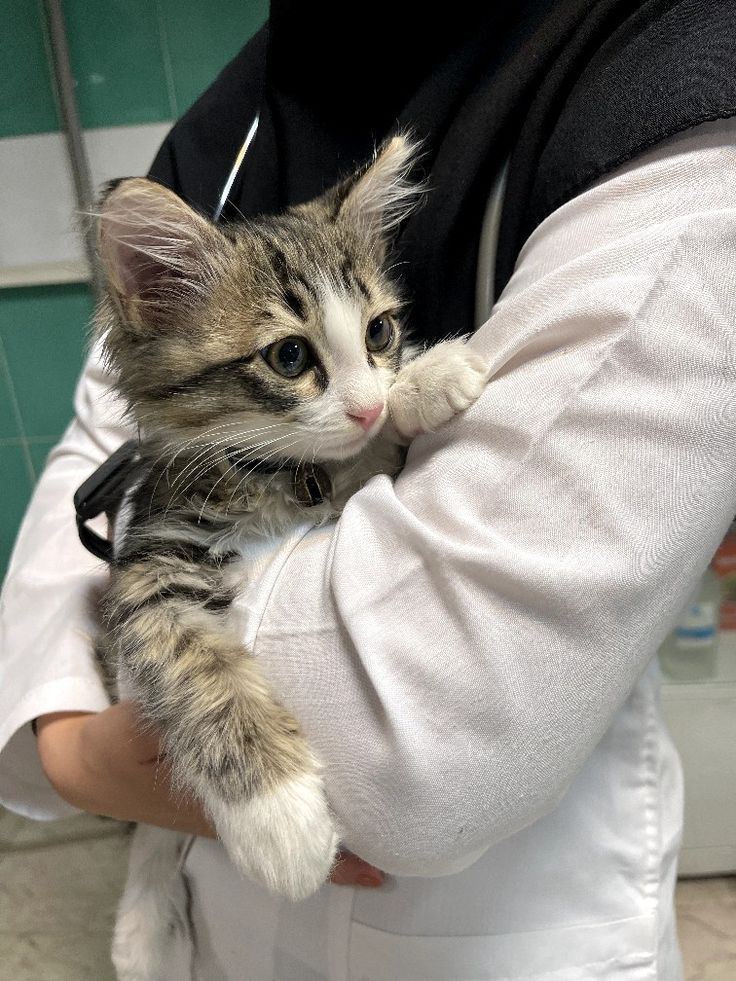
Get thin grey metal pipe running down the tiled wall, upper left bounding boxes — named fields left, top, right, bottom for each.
left=44, top=0, right=102, bottom=297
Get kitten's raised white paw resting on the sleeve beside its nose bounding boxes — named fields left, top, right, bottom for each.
left=388, top=339, right=490, bottom=439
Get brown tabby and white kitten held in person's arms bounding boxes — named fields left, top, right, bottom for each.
left=97, top=137, right=488, bottom=981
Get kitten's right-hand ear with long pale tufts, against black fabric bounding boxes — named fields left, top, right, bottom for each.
left=336, top=136, right=423, bottom=240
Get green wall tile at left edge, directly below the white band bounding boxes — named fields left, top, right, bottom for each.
left=0, top=283, right=93, bottom=437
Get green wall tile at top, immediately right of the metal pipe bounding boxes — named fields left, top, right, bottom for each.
left=64, top=0, right=174, bottom=127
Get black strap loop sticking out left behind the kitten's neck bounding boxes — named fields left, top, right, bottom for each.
left=74, top=439, right=140, bottom=562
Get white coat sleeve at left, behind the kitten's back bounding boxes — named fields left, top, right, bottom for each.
left=0, top=350, right=130, bottom=819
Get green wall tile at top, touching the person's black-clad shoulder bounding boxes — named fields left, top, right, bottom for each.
left=157, top=0, right=268, bottom=116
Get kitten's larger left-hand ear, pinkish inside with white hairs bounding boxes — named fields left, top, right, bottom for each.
left=97, top=177, right=224, bottom=328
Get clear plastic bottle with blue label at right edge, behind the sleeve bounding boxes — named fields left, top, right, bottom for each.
left=659, top=566, right=721, bottom=681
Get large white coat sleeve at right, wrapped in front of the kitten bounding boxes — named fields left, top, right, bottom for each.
left=243, top=122, right=736, bottom=875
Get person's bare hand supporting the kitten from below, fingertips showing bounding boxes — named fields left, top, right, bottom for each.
left=36, top=702, right=383, bottom=886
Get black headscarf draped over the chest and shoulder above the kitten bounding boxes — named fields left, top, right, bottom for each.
left=151, top=0, right=736, bottom=341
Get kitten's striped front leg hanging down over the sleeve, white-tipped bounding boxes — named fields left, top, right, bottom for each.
left=106, top=553, right=339, bottom=899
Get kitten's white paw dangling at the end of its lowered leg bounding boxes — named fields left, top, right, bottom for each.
left=206, top=773, right=339, bottom=899
